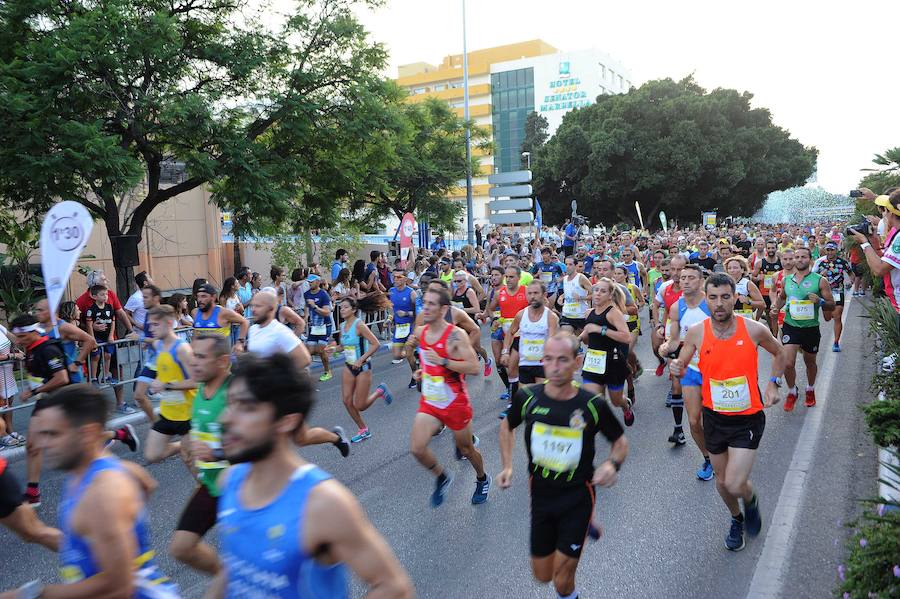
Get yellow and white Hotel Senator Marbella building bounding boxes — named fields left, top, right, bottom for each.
left=397, top=40, right=632, bottom=223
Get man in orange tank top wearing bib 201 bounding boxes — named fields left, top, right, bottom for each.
left=673, top=273, right=787, bottom=551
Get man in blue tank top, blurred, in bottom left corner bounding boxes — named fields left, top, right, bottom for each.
left=11, top=384, right=180, bottom=599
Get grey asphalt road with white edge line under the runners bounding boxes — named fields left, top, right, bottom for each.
left=0, top=301, right=877, bottom=599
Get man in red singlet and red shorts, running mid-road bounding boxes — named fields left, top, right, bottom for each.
left=407, top=286, right=492, bottom=507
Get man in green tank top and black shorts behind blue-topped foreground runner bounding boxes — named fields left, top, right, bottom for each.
left=169, top=333, right=231, bottom=574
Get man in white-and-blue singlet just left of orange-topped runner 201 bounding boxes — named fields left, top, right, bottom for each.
left=659, top=264, right=714, bottom=480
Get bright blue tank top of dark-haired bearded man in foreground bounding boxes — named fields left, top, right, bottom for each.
left=218, top=464, right=349, bottom=599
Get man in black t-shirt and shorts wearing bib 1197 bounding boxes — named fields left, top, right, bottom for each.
left=497, top=332, right=628, bottom=599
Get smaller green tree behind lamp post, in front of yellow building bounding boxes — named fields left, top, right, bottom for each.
left=351, top=98, right=487, bottom=231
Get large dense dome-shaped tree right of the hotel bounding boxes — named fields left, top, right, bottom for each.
left=536, top=77, right=817, bottom=225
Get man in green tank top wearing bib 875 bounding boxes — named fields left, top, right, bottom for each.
left=773, top=247, right=834, bottom=412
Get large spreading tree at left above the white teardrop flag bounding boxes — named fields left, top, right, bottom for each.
left=0, top=0, right=386, bottom=297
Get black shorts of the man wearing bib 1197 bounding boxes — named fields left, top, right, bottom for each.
left=531, top=481, right=594, bottom=558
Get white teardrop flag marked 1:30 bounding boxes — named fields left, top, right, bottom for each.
left=41, top=201, right=94, bottom=325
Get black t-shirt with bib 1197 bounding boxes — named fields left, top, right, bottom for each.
left=506, top=385, right=624, bottom=489
